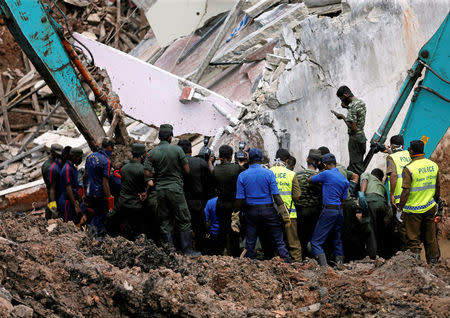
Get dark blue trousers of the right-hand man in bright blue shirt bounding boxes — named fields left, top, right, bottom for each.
left=311, top=208, right=344, bottom=256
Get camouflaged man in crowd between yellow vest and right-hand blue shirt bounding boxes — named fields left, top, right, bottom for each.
left=294, top=149, right=322, bottom=259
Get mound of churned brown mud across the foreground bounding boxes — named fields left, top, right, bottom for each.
left=0, top=214, right=450, bottom=317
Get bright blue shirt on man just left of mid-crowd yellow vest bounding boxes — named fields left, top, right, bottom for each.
left=236, top=164, right=280, bottom=205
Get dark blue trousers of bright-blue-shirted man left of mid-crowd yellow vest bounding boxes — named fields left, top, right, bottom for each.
left=245, top=207, right=290, bottom=258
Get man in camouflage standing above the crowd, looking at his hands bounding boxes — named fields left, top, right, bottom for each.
left=336, top=86, right=367, bottom=175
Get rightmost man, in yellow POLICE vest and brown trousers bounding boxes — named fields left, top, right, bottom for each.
left=398, top=140, right=440, bottom=263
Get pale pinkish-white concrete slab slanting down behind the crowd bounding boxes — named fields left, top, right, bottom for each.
left=75, top=34, right=243, bottom=136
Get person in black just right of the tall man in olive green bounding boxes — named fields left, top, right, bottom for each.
left=178, top=139, right=214, bottom=250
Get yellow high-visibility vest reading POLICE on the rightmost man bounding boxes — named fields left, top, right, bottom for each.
left=403, top=158, right=439, bottom=213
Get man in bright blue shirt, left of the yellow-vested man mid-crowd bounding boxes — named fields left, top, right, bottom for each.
left=236, top=148, right=292, bottom=263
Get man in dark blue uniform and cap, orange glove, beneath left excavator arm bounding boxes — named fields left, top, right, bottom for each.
left=85, top=137, right=114, bottom=232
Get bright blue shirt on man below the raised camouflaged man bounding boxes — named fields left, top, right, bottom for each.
left=311, top=168, right=349, bottom=205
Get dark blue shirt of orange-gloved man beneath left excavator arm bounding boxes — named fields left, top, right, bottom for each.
left=86, top=149, right=111, bottom=198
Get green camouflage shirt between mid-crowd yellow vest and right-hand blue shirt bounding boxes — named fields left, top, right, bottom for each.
left=295, top=169, right=322, bottom=208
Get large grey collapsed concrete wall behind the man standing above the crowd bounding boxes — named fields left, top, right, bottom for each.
left=217, top=0, right=450, bottom=166
